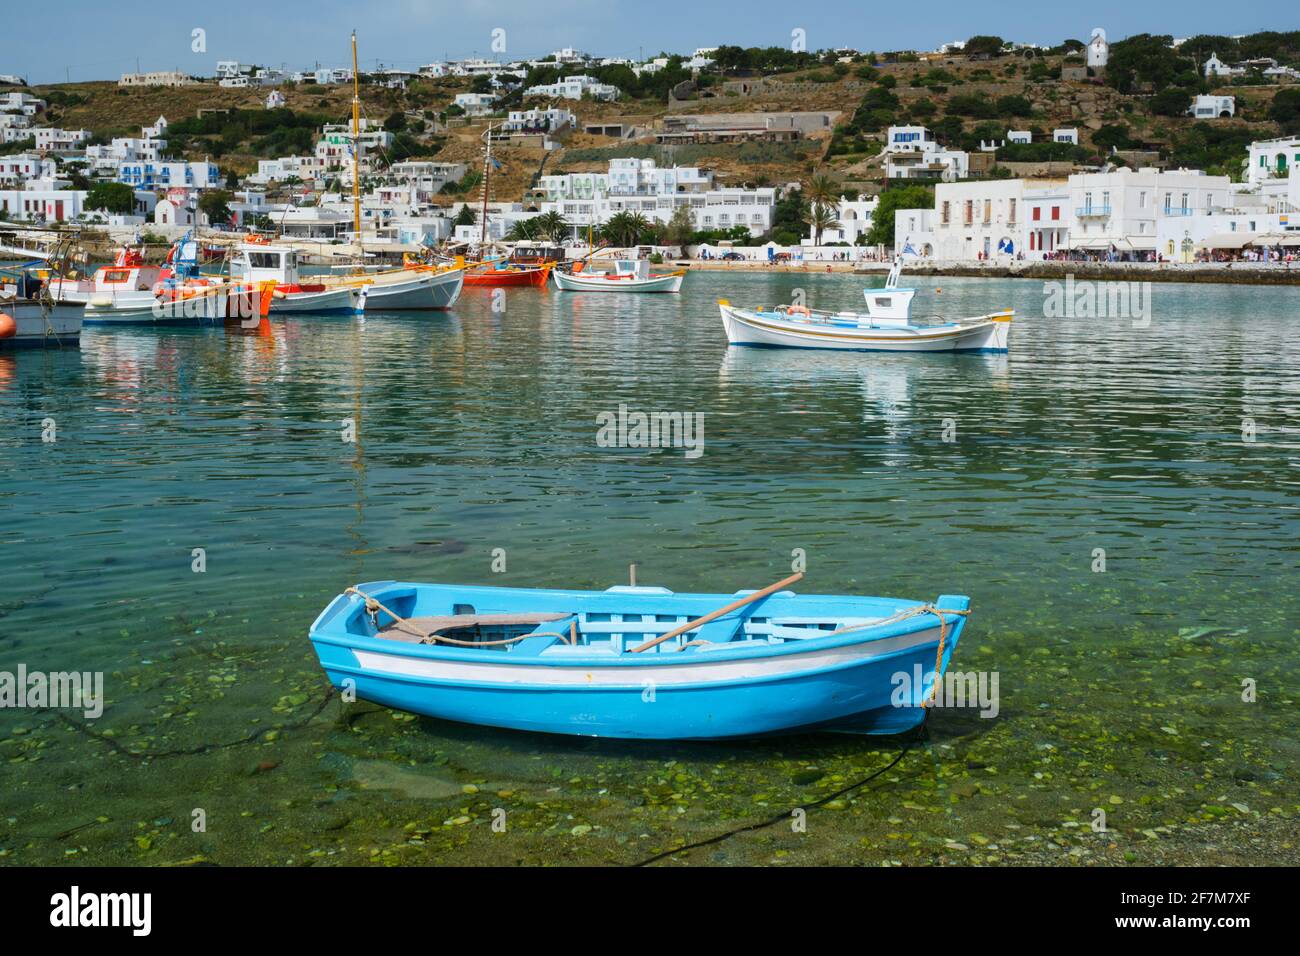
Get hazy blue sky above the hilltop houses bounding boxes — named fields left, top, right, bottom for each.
left=0, top=0, right=1296, bottom=83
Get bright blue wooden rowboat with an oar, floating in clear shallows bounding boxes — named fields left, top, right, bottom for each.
left=311, top=575, right=970, bottom=740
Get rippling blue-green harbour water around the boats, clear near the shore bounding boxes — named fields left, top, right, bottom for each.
left=0, top=273, right=1300, bottom=864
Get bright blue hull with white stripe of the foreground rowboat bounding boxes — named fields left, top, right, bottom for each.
left=312, top=583, right=969, bottom=740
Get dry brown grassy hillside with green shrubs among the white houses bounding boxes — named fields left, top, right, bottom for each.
left=22, top=46, right=1296, bottom=202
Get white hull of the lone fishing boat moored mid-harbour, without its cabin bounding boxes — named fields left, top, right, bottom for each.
left=718, top=299, right=1015, bottom=352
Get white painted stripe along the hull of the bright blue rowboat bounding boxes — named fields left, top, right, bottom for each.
left=352, top=627, right=939, bottom=689
